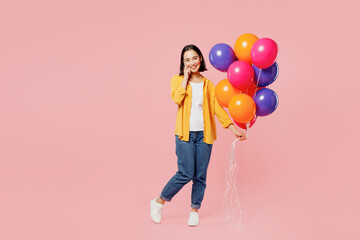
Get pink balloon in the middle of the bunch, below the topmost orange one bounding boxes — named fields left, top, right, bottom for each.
left=227, top=60, right=254, bottom=91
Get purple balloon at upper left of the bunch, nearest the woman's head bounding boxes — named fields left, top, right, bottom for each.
left=209, top=43, right=236, bottom=72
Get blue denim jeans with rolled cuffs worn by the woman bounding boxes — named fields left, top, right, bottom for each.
left=160, top=131, right=212, bottom=209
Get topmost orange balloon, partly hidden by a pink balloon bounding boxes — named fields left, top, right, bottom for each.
left=234, top=33, right=259, bottom=64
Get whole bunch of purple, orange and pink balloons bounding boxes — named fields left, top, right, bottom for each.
left=209, top=33, right=279, bottom=129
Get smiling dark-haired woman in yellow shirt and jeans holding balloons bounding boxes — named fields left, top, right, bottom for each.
left=150, top=45, right=246, bottom=226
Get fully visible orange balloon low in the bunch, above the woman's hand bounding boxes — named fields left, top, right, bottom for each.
left=229, top=93, right=256, bottom=123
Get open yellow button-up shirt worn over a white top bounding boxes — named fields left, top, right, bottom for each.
left=170, top=74, right=234, bottom=144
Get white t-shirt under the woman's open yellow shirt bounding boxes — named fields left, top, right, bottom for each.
left=189, top=82, right=204, bottom=131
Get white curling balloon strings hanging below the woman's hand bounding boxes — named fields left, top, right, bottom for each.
left=223, top=139, right=255, bottom=229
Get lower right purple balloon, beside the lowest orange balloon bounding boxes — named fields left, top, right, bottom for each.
left=253, top=88, right=279, bottom=117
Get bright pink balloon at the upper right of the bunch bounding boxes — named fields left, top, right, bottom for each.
left=251, top=38, right=278, bottom=69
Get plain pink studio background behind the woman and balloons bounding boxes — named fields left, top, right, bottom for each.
left=0, top=0, right=360, bottom=240
